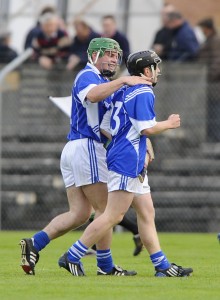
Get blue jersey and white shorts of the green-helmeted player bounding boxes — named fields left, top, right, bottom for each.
left=60, top=63, right=111, bottom=187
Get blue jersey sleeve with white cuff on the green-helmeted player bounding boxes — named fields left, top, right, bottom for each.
left=74, top=70, right=100, bottom=106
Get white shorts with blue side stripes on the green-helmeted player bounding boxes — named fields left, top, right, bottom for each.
left=60, top=138, right=108, bottom=188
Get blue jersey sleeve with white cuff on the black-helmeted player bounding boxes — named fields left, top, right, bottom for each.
left=124, top=86, right=157, bottom=133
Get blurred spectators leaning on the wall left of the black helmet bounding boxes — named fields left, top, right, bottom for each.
left=0, top=6, right=130, bottom=70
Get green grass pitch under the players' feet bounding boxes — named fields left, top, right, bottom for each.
left=0, top=232, right=220, bottom=300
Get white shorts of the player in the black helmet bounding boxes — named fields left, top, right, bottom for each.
left=108, top=171, right=150, bottom=195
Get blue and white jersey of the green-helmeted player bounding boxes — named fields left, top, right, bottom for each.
left=68, top=63, right=111, bottom=142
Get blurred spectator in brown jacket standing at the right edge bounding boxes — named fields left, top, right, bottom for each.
left=198, top=18, right=220, bottom=142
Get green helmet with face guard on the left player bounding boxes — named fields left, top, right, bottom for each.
left=87, top=38, right=122, bottom=77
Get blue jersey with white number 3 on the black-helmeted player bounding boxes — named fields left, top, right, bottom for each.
left=107, top=85, right=156, bottom=178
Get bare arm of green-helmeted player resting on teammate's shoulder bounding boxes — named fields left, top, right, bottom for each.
left=86, top=76, right=152, bottom=103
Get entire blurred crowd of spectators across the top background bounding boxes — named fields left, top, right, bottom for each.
left=0, top=4, right=220, bottom=141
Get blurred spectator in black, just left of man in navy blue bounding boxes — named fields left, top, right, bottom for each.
left=152, top=3, right=175, bottom=60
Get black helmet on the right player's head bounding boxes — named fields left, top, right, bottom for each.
left=126, top=50, right=162, bottom=76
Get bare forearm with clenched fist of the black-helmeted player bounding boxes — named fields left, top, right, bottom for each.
left=141, top=114, right=180, bottom=135
